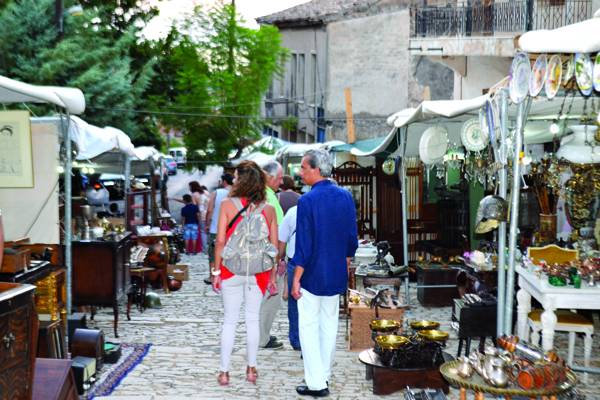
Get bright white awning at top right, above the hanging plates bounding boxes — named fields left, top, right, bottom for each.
left=518, top=12, right=600, bottom=53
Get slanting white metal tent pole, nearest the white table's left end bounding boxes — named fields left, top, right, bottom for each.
left=504, top=97, right=531, bottom=335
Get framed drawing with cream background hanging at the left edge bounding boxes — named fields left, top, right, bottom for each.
left=0, top=111, right=33, bottom=188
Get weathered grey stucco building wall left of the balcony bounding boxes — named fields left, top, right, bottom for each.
left=326, top=9, right=453, bottom=141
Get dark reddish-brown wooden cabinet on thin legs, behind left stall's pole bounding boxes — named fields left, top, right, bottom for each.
left=72, top=233, right=131, bottom=337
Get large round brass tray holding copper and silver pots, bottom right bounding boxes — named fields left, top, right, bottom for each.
left=440, top=360, right=577, bottom=398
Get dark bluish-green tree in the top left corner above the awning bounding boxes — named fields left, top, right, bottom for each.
left=0, top=0, right=153, bottom=144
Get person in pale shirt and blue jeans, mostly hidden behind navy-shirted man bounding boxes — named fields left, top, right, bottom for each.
left=279, top=206, right=300, bottom=350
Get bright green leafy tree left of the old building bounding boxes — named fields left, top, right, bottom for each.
left=164, top=4, right=287, bottom=160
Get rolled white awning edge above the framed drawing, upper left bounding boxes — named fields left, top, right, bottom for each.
left=0, top=76, right=85, bottom=114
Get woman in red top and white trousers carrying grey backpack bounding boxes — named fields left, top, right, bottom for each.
left=211, top=161, right=278, bottom=385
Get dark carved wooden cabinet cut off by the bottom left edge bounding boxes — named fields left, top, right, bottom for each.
left=0, top=282, right=38, bottom=400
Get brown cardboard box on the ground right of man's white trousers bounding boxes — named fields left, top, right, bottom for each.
left=348, top=304, right=404, bottom=351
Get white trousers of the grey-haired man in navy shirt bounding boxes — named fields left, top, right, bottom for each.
left=298, top=289, right=340, bottom=390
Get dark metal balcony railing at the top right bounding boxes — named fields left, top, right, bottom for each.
left=411, top=0, right=592, bottom=37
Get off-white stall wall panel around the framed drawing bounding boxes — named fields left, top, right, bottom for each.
left=0, top=123, right=59, bottom=243
